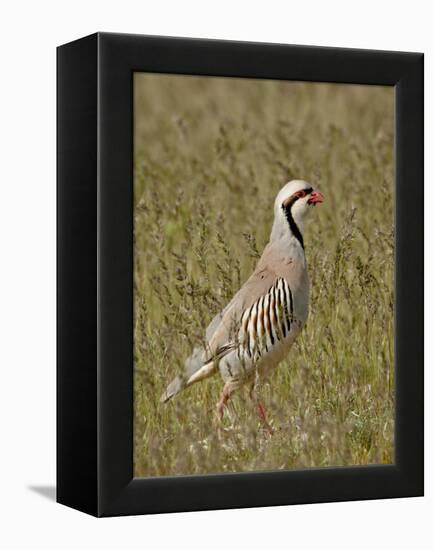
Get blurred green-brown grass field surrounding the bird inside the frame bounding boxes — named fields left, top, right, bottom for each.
left=134, top=74, right=394, bottom=477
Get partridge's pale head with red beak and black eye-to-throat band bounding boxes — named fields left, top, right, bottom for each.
left=272, top=180, right=324, bottom=246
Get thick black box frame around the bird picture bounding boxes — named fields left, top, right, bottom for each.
left=57, top=33, right=423, bottom=516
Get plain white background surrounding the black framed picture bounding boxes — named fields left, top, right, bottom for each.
left=0, top=0, right=434, bottom=550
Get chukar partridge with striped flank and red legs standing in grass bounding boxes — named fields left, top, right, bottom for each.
left=161, top=180, right=324, bottom=432
